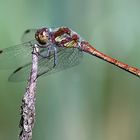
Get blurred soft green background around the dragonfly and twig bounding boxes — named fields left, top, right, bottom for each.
left=0, top=0, right=140, bottom=140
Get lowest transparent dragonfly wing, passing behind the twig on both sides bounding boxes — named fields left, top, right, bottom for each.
left=9, top=48, right=82, bottom=82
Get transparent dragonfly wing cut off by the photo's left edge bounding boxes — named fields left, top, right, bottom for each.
left=0, top=41, right=35, bottom=69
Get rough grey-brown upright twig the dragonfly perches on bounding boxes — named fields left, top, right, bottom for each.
left=19, top=45, right=39, bottom=140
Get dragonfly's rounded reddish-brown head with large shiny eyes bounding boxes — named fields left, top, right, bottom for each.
left=35, top=28, right=49, bottom=45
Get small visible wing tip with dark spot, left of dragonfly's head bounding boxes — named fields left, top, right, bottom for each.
left=21, top=29, right=37, bottom=43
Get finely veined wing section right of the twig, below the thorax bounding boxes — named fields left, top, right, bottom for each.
left=38, top=48, right=83, bottom=76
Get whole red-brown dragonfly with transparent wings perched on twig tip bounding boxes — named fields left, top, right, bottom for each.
left=0, top=27, right=140, bottom=82
